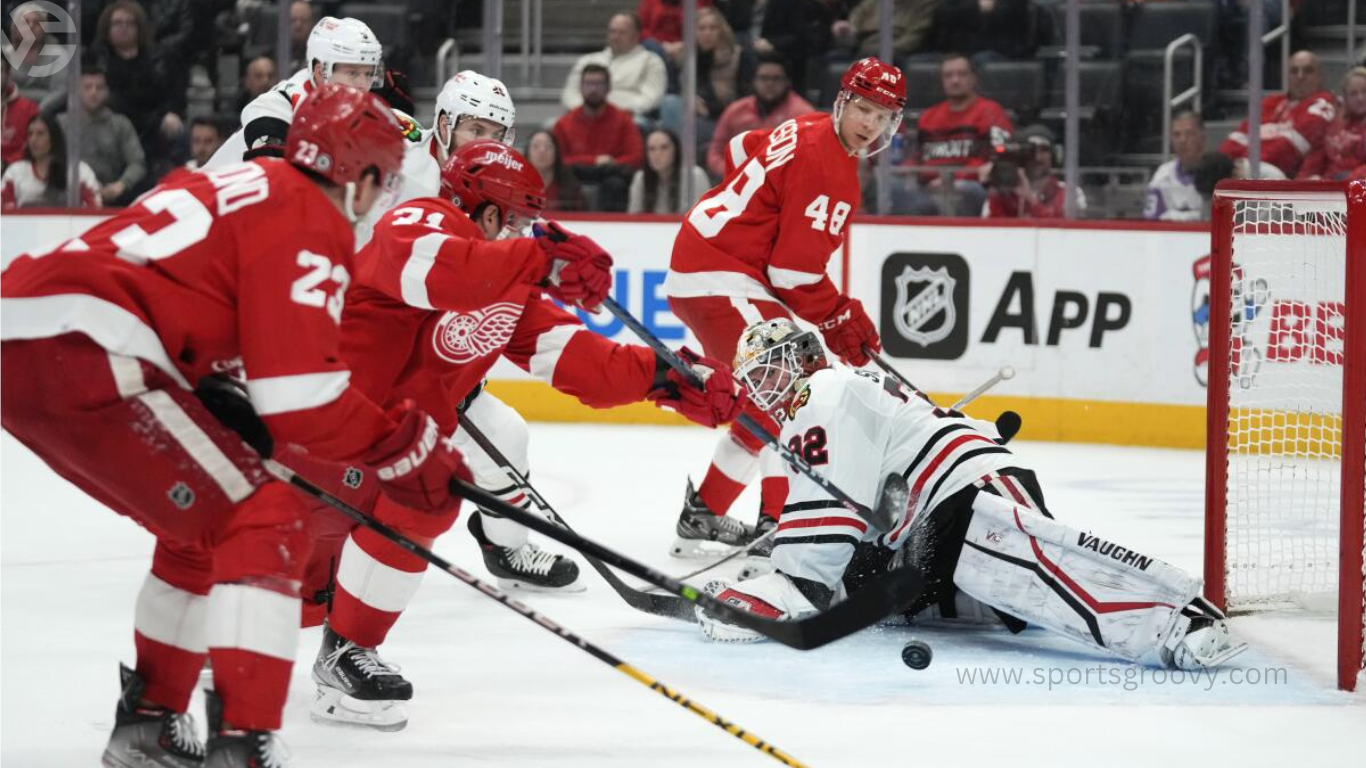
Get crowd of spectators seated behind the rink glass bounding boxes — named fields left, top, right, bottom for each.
left=3, top=0, right=1366, bottom=220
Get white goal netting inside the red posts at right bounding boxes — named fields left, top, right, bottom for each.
left=1225, top=197, right=1349, bottom=611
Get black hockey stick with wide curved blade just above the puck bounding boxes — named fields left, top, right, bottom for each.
left=451, top=476, right=925, bottom=650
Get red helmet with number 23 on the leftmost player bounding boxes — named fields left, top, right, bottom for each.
left=284, top=83, right=404, bottom=189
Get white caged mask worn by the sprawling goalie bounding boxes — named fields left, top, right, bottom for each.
left=735, top=317, right=829, bottom=413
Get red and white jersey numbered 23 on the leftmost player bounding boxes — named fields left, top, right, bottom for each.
left=0, top=159, right=393, bottom=459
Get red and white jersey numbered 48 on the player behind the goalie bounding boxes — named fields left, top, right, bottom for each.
left=664, top=113, right=861, bottom=323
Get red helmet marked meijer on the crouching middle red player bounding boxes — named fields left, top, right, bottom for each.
left=441, top=139, right=545, bottom=230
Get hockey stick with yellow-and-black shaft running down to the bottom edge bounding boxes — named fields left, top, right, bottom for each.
left=264, top=459, right=807, bottom=768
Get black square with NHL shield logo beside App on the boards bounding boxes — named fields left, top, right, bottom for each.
left=880, top=253, right=970, bottom=359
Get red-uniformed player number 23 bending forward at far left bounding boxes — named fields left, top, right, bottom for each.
left=0, top=85, right=467, bottom=768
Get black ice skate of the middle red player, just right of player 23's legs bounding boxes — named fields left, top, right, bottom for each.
left=310, top=617, right=413, bottom=731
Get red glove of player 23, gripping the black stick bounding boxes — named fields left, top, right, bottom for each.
left=365, top=400, right=470, bottom=514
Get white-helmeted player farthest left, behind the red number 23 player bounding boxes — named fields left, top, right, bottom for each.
left=204, top=16, right=384, bottom=168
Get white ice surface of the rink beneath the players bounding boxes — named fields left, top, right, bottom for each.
left=0, top=424, right=1366, bottom=768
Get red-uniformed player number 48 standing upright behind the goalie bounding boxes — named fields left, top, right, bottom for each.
left=664, top=59, right=906, bottom=556
